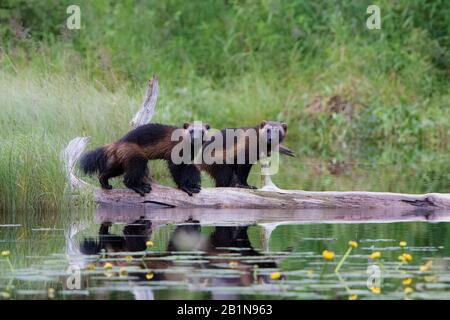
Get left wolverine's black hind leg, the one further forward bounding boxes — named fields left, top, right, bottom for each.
left=123, top=156, right=151, bottom=196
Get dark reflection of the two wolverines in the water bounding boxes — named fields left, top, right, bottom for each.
left=80, top=218, right=277, bottom=299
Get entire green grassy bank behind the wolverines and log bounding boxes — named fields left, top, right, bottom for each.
left=0, top=0, right=450, bottom=216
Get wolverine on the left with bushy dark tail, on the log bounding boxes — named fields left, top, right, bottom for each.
left=80, top=123, right=209, bottom=196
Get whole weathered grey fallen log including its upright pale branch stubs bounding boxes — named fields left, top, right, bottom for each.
left=62, top=76, right=450, bottom=210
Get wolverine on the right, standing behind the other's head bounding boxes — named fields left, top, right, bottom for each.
left=199, top=121, right=294, bottom=189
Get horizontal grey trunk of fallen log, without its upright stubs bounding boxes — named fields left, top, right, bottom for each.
left=94, top=184, right=450, bottom=210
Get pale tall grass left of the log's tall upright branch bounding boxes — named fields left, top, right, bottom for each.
left=0, top=72, right=137, bottom=215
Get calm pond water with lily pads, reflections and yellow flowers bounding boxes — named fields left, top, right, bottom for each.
left=0, top=208, right=450, bottom=299
